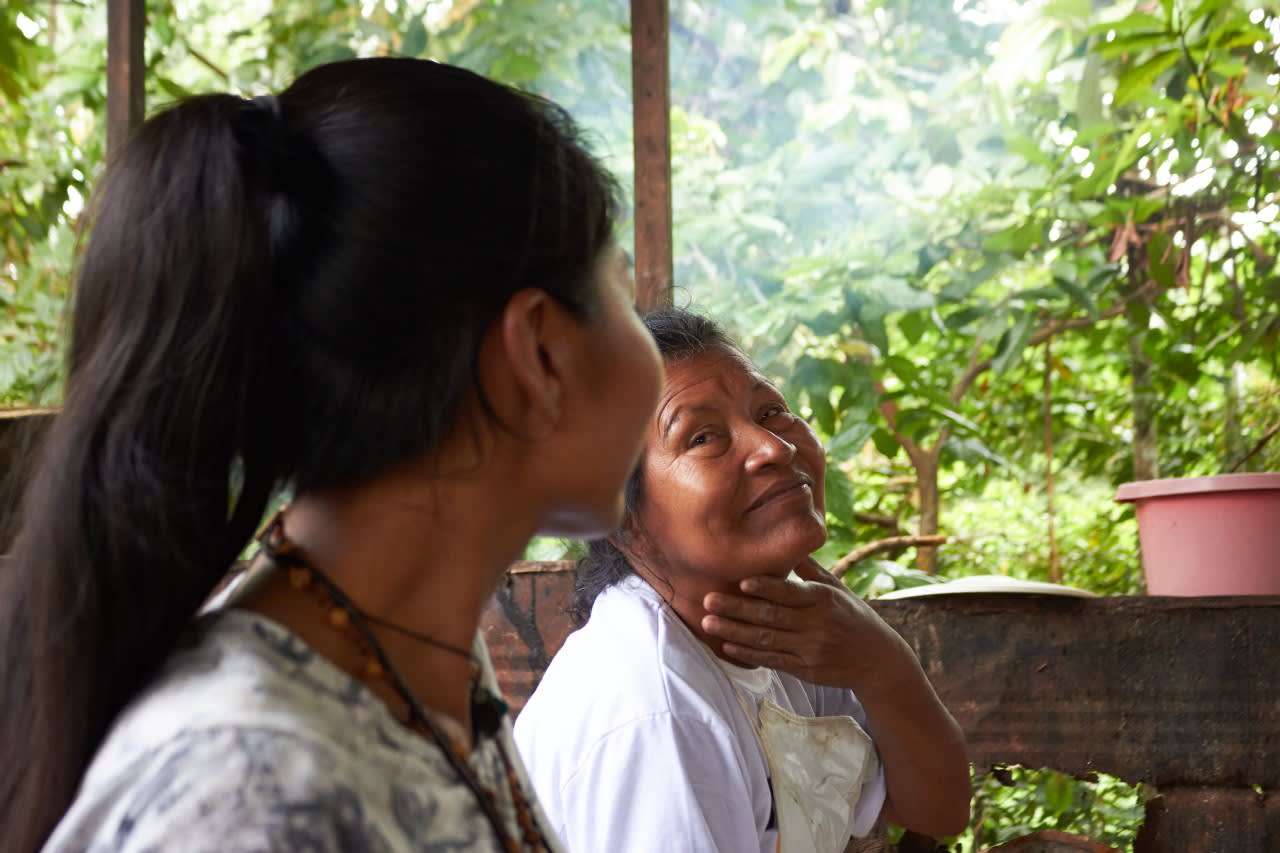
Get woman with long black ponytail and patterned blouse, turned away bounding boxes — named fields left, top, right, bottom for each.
left=0, top=58, right=660, bottom=853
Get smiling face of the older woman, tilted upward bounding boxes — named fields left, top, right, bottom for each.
left=639, top=350, right=827, bottom=583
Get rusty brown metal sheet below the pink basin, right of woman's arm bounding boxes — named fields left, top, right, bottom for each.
left=873, top=596, right=1280, bottom=789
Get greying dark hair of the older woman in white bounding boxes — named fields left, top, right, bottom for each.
left=568, top=307, right=741, bottom=624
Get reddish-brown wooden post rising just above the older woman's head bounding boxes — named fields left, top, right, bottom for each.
left=631, top=0, right=673, bottom=310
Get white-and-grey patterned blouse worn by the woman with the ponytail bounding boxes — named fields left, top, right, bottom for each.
left=44, top=610, right=554, bottom=853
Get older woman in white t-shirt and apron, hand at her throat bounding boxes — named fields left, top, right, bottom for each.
left=516, top=310, right=969, bottom=853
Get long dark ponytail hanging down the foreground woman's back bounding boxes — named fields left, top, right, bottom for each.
left=0, top=96, right=297, bottom=853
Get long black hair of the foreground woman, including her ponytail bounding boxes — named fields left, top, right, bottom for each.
left=0, top=58, right=616, bottom=852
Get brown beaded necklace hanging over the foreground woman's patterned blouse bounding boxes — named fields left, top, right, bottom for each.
left=257, top=507, right=550, bottom=853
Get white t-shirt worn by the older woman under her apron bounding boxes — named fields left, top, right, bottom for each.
left=516, top=578, right=884, bottom=853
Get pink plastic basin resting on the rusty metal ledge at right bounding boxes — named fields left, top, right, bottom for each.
left=1116, top=474, right=1280, bottom=596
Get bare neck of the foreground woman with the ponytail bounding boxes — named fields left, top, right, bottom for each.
left=244, top=450, right=536, bottom=731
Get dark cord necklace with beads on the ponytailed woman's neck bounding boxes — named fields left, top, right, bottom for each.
left=257, top=508, right=548, bottom=853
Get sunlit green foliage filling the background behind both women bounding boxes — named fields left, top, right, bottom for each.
left=0, top=0, right=1280, bottom=850
